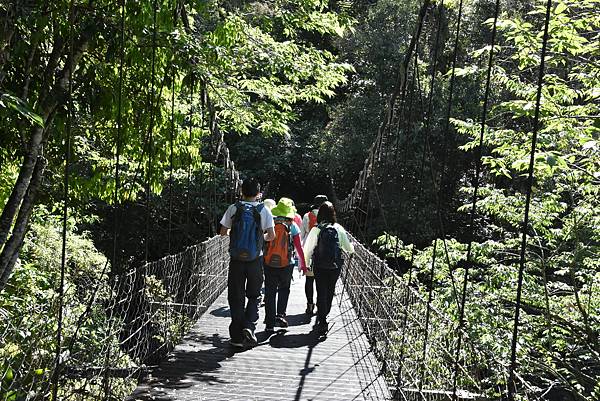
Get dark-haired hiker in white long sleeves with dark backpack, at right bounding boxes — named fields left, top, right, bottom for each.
left=304, top=201, right=354, bottom=335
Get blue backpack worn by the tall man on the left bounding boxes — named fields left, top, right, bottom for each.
left=229, top=202, right=264, bottom=262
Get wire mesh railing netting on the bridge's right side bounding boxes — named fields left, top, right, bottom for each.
left=342, top=231, right=507, bottom=401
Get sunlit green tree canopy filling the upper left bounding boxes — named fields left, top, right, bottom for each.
left=0, top=0, right=352, bottom=211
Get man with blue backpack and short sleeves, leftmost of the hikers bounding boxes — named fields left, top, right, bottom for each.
left=221, top=179, right=275, bottom=347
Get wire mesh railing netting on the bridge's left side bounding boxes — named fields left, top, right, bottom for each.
left=0, top=236, right=229, bottom=401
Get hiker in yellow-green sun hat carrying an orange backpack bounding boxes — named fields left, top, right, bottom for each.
left=264, top=198, right=306, bottom=333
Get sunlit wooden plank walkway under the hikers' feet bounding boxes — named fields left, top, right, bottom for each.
left=128, top=273, right=391, bottom=401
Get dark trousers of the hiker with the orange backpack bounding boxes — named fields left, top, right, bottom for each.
left=265, top=265, right=294, bottom=327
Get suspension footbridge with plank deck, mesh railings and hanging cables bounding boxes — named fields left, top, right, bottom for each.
left=0, top=1, right=576, bottom=401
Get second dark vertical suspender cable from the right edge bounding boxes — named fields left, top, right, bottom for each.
left=452, top=0, right=500, bottom=401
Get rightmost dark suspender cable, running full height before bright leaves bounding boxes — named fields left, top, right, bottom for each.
left=508, top=0, right=552, bottom=401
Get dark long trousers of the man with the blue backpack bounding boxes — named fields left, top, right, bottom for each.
left=227, top=258, right=263, bottom=342
